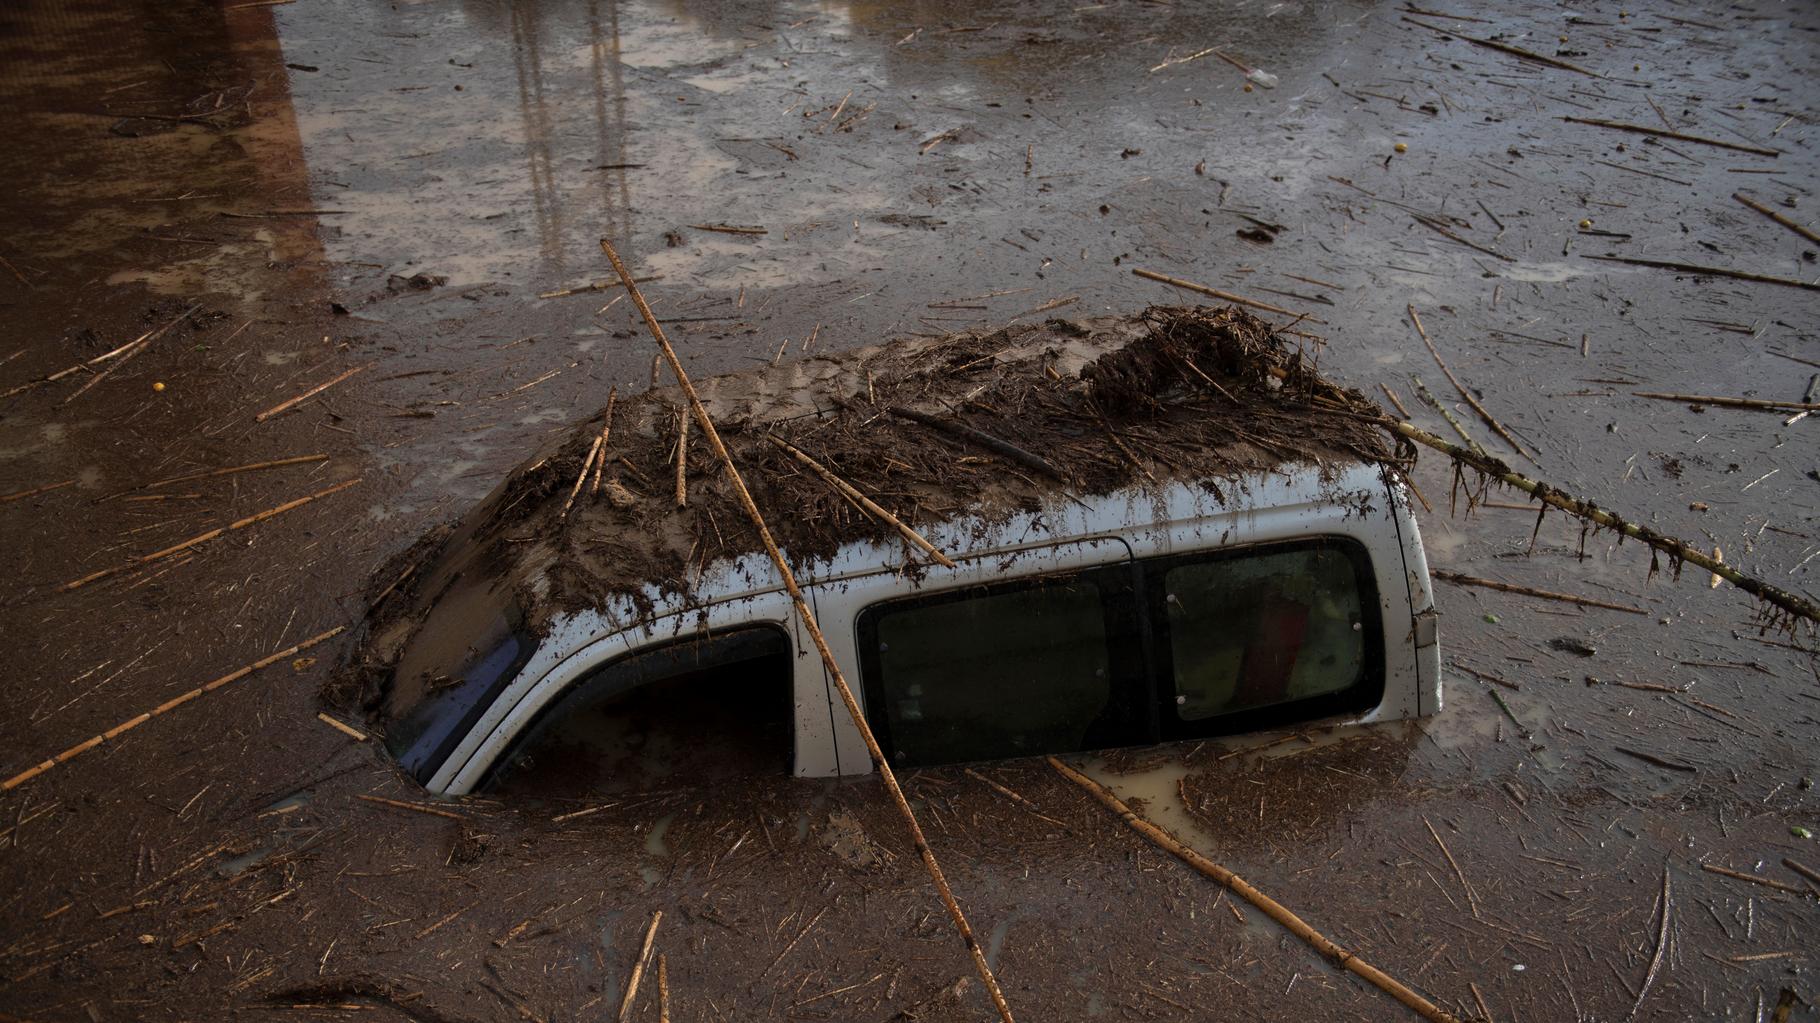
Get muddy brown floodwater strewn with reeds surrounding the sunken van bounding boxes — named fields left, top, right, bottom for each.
left=0, top=0, right=1820, bottom=1021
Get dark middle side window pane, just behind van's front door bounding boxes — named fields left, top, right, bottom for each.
left=859, top=564, right=1148, bottom=766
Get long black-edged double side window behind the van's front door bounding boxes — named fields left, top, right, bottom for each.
left=859, top=537, right=1383, bottom=766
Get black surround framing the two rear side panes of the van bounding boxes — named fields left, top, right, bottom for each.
left=854, top=533, right=1385, bottom=768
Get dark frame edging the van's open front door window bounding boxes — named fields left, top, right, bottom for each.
left=473, top=621, right=797, bottom=794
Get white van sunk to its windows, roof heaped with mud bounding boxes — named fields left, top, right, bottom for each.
left=351, top=309, right=1441, bottom=794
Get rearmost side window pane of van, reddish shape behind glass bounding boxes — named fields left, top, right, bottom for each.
left=1152, top=541, right=1383, bottom=737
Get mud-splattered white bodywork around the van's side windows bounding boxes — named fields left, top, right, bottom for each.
left=428, top=462, right=1441, bottom=795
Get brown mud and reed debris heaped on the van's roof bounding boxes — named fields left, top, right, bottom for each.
left=338, top=308, right=1394, bottom=709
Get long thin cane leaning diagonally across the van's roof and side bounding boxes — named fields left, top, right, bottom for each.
left=601, top=238, right=1014, bottom=1023
